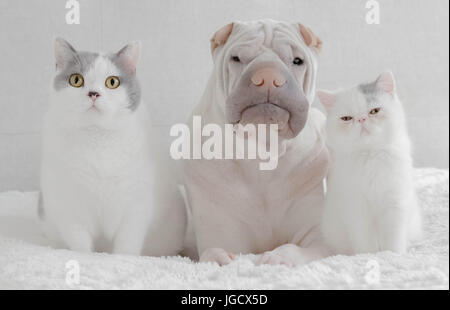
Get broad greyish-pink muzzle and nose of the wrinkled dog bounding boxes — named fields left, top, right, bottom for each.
left=226, top=63, right=309, bottom=139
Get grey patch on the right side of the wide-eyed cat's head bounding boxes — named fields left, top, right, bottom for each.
left=107, top=51, right=141, bottom=111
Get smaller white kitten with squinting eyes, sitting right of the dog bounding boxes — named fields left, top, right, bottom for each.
left=317, top=72, right=421, bottom=254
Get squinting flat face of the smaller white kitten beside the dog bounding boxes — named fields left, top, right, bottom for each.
left=318, top=71, right=402, bottom=150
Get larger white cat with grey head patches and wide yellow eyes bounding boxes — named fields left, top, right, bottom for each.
left=40, top=39, right=186, bottom=255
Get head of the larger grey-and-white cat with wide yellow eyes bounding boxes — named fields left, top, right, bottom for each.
left=52, top=39, right=141, bottom=125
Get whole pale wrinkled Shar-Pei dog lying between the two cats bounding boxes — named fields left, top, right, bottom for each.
left=184, top=20, right=328, bottom=265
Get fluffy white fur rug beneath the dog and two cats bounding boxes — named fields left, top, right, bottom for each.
left=0, top=169, right=449, bottom=289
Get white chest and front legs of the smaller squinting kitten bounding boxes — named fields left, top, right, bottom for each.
left=323, top=151, right=408, bottom=253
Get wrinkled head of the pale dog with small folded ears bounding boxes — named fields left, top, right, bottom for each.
left=211, top=21, right=322, bottom=138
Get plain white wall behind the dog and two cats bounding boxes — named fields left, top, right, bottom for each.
left=0, top=0, right=449, bottom=191
